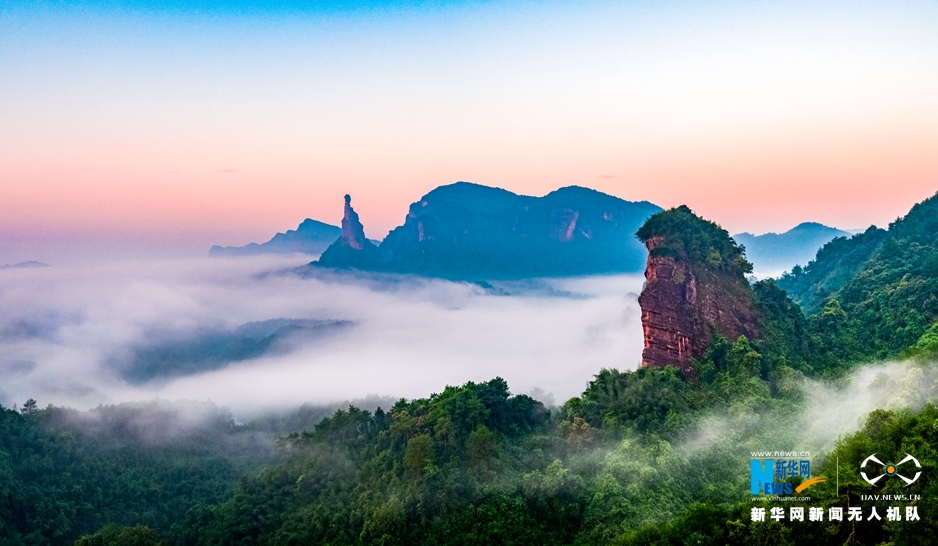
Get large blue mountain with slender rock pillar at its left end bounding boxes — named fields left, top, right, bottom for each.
left=315, top=182, right=662, bottom=280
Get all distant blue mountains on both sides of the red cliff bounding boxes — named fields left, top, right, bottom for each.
left=209, top=182, right=850, bottom=279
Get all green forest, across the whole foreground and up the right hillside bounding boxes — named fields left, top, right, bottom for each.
left=0, top=190, right=938, bottom=546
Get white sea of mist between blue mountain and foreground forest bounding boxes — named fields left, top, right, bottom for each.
left=0, top=256, right=643, bottom=416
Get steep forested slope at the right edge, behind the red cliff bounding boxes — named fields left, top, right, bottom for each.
left=778, top=191, right=938, bottom=363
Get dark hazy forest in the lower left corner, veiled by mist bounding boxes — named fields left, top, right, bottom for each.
left=0, top=400, right=274, bottom=546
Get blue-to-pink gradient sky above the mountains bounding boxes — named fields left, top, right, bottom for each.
left=0, top=0, right=938, bottom=263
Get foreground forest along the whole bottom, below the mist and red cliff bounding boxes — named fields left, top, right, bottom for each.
left=0, top=346, right=938, bottom=545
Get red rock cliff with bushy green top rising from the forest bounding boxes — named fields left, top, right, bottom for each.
left=638, top=206, right=762, bottom=376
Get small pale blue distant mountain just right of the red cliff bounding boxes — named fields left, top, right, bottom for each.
left=733, top=222, right=850, bottom=272
